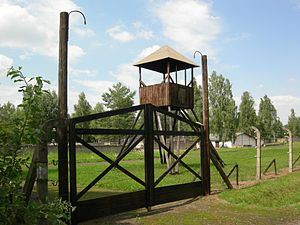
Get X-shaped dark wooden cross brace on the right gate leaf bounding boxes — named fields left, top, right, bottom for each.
left=154, top=137, right=202, bottom=187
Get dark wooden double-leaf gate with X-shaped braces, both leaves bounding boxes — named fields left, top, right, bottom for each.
left=69, top=104, right=203, bottom=224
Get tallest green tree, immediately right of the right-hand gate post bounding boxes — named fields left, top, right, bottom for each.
left=209, top=71, right=237, bottom=143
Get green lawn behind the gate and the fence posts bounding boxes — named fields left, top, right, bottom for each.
left=26, top=143, right=300, bottom=200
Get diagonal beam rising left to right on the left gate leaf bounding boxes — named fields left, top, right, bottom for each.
left=76, top=136, right=144, bottom=199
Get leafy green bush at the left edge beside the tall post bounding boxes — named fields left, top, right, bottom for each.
left=0, top=67, right=70, bottom=225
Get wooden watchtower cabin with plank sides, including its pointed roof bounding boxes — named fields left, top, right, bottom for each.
left=134, top=46, right=198, bottom=109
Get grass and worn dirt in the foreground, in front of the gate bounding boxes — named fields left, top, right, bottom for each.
left=82, top=172, right=300, bottom=225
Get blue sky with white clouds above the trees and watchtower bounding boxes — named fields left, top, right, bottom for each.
left=0, top=0, right=300, bottom=124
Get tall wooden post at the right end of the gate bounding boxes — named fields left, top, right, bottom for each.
left=201, top=55, right=210, bottom=195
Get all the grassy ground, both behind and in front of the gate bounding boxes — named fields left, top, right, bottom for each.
left=21, top=143, right=300, bottom=224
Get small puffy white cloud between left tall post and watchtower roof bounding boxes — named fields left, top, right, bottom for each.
left=106, top=21, right=153, bottom=42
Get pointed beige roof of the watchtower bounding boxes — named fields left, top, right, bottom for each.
left=134, top=45, right=198, bottom=73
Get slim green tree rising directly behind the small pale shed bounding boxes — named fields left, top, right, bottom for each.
left=237, top=91, right=257, bottom=134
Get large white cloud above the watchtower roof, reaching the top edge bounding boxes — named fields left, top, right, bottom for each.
left=154, top=0, right=221, bottom=56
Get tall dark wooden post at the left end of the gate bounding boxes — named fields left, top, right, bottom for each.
left=57, top=12, right=69, bottom=200
